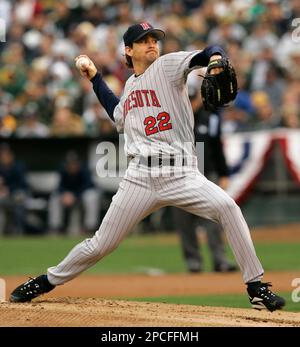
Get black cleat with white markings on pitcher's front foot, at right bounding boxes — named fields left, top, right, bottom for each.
left=247, top=282, right=285, bottom=312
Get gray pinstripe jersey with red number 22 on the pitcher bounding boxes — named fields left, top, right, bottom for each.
left=114, top=51, right=200, bottom=156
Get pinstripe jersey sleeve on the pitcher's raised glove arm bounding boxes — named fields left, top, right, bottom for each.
left=160, top=51, right=201, bottom=87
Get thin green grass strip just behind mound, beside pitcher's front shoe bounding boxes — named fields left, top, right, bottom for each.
left=122, top=292, right=300, bottom=312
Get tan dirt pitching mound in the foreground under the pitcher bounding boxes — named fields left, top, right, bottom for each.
left=0, top=297, right=300, bottom=327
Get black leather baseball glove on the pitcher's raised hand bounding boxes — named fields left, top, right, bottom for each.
left=201, top=58, right=238, bottom=111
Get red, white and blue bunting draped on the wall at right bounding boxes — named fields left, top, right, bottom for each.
left=223, top=129, right=300, bottom=203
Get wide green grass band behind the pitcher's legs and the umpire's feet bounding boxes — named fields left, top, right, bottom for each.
left=0, top=234, right=300, bottom=275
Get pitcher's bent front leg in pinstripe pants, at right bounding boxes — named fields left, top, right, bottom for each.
left=170, top=173, right=263, bottom=282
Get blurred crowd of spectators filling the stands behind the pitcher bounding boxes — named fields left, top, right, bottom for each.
left=0, top=0, right=300, bottom=138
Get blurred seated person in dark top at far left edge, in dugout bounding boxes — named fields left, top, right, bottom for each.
left=0, top=143, right=27, bottom=234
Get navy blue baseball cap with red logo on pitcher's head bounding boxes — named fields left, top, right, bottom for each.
left=123, top=22, right=165, bottom=46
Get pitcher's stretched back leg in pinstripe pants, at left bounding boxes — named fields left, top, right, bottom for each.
left=47, top=180, right=156, bottom=285
